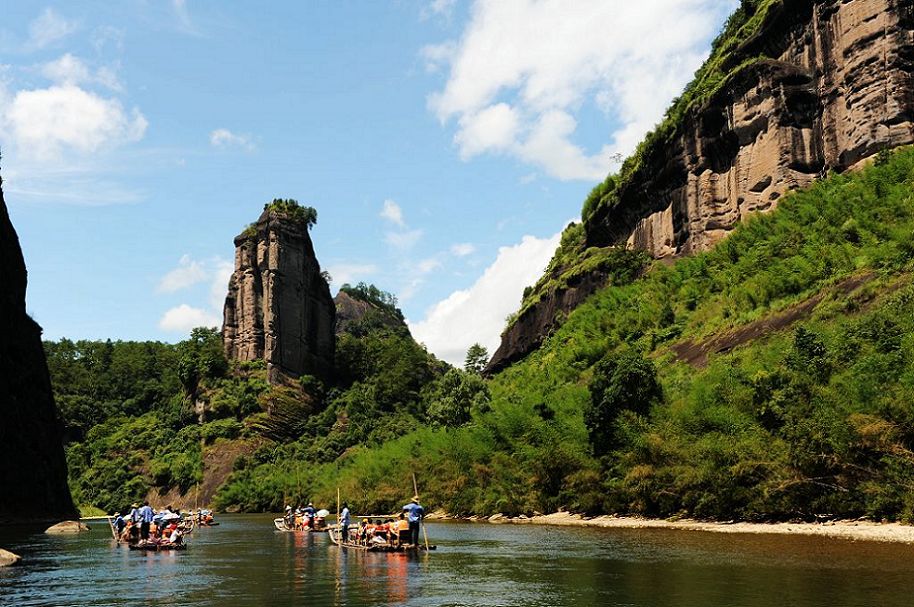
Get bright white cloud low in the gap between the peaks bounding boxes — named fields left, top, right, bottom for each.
left=409, top=232, right=562, bottom=365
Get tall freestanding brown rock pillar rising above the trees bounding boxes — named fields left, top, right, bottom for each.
left=222, top=210, right=336, bottom=383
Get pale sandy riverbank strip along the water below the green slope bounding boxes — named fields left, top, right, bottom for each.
left=427, top=512, right=914, bottom=544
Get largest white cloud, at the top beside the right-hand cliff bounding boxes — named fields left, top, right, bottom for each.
left=422, top=0, right=736, bottom=181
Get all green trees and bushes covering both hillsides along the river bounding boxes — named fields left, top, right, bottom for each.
left=47, top=149, right=914, bottom=520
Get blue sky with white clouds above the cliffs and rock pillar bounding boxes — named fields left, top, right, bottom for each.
left=0, top=0, right=735, bottom=362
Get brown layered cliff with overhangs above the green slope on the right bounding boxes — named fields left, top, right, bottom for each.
left=487, top=0, right=914, bottom=373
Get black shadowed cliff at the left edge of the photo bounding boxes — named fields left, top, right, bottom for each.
left=0, top=180, right=76, bottom=522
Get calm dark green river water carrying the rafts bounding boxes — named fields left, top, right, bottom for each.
left=0, top=515, right=914, bottom=607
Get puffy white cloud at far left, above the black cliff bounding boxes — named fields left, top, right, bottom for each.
left=0, top=83, right=149, bottom=159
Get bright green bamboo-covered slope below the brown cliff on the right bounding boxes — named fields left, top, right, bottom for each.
left=266, top=150, right=914, bottom=519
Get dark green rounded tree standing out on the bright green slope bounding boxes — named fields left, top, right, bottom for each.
left=584, top=350, right=663, bottom=456
